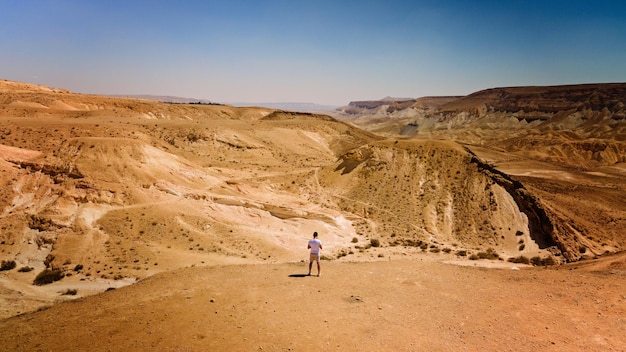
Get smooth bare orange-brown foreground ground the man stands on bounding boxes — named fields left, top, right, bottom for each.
left=0, top=254, right=626, bottom=351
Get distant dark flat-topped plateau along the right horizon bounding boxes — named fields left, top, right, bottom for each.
left=337, top=83, right=626, bottom=141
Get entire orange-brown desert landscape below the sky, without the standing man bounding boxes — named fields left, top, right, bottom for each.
left=0, top=81, right=626, bottom=351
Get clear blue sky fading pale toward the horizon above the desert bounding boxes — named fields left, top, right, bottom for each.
left=0, top=0, right=626, bottom=105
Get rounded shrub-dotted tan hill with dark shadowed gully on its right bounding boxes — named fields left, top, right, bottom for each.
left=322, top=140, right=560, bottom=259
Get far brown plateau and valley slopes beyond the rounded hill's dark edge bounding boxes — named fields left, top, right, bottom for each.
left=340, top=83, right=626, bottom=260
